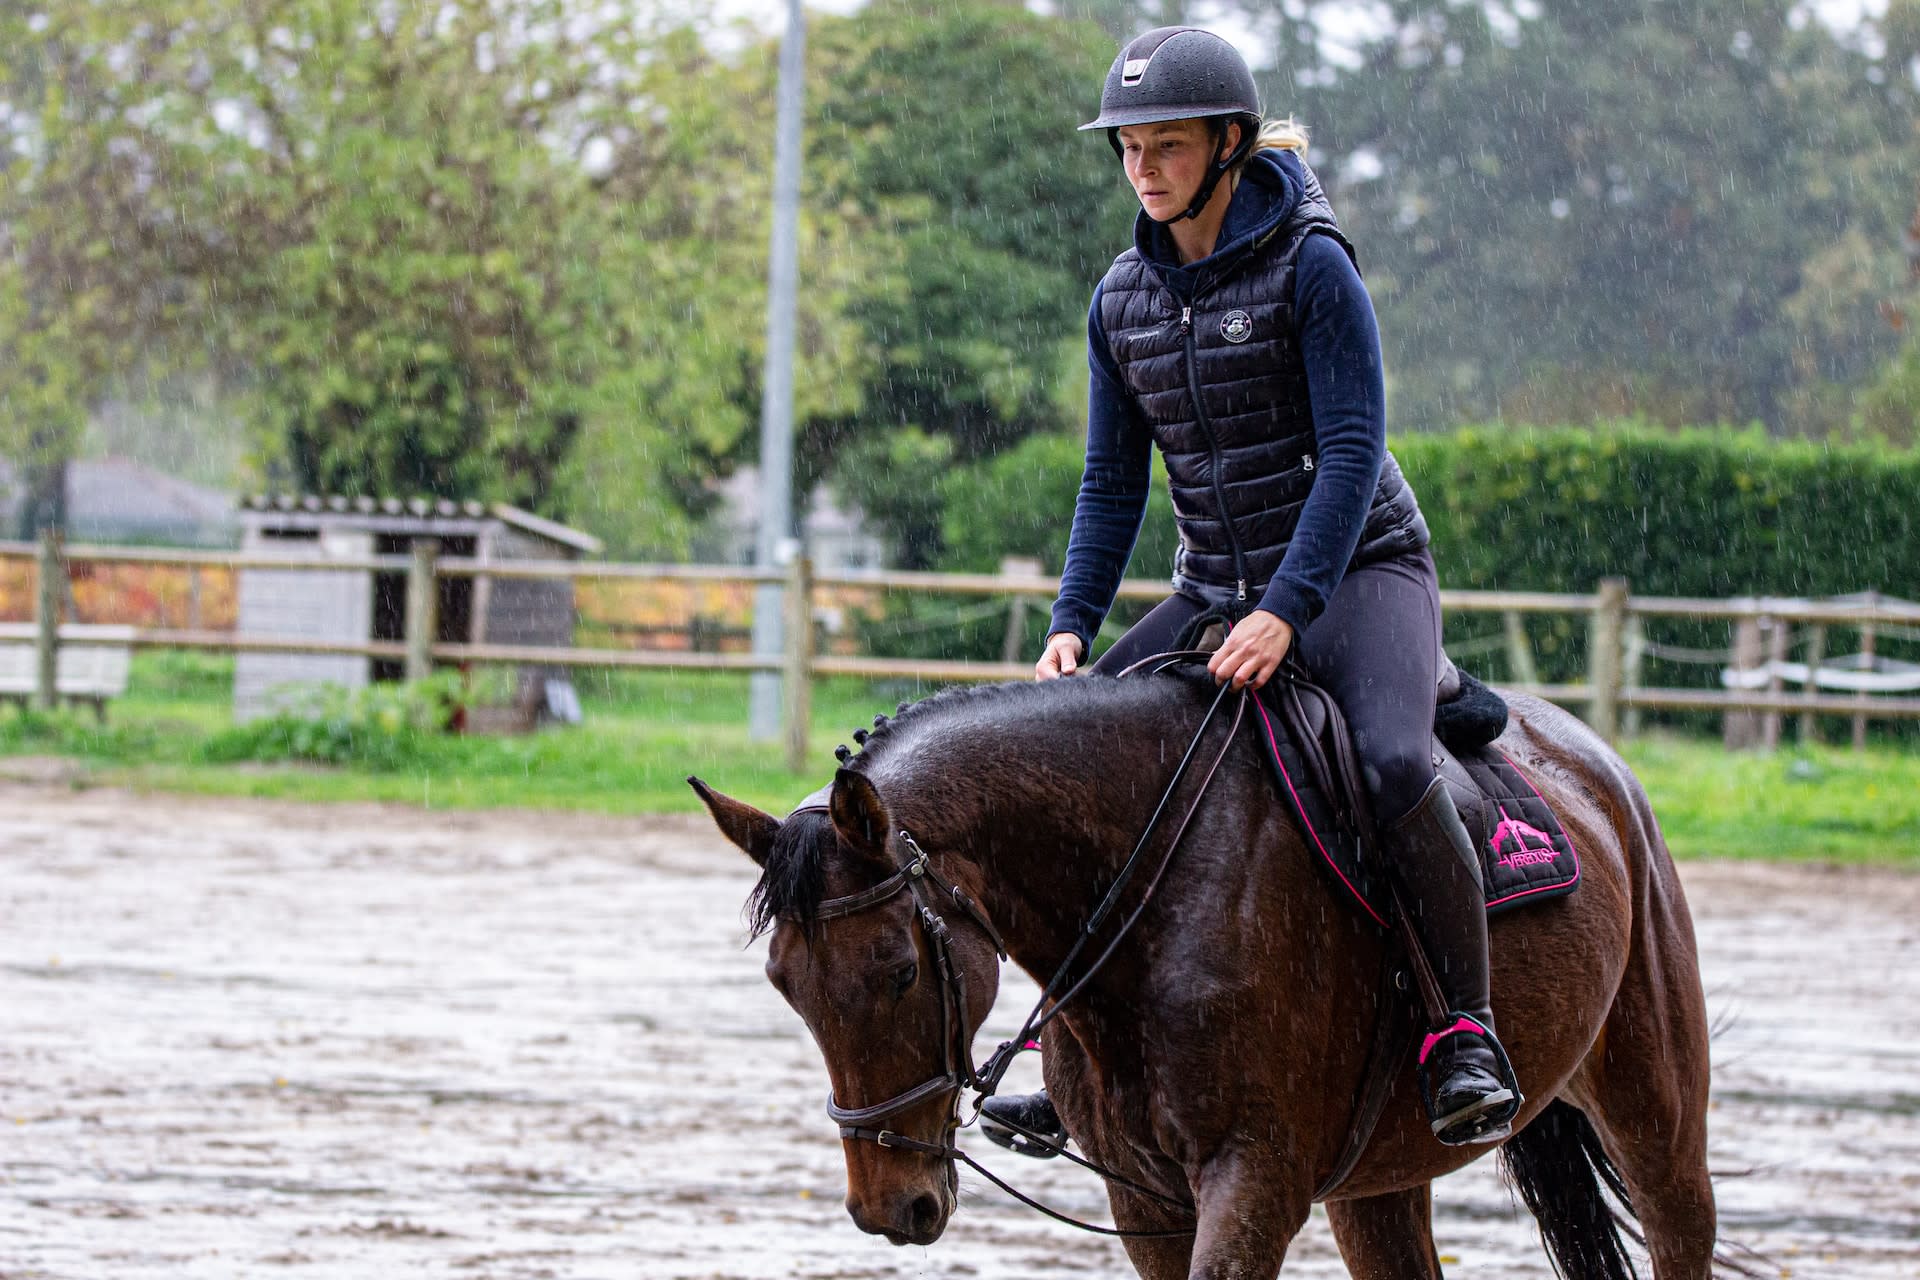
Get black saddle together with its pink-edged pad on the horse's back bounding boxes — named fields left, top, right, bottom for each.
left=1254, top=660, right=1580, bottom=929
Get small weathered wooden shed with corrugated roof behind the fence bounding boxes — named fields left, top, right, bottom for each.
left=234, top=495, right=601, bottom=723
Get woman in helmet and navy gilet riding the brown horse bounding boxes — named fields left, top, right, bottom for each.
left=987, top=27, right=1519, bottom=1153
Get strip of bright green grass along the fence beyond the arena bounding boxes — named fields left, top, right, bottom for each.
left=0, top=654, right=1920, bottom=867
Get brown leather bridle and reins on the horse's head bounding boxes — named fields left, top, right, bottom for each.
left=789, top=651, right=1252, bottom=1238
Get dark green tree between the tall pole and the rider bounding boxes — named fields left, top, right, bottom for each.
left=806, top=0, right=1133, bottom=564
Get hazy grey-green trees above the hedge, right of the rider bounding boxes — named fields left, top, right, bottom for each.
left=1263, top=0, right=1916, bottom=432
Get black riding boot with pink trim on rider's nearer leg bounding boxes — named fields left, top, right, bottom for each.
left=1386, top=777, right=1521, bottom=1146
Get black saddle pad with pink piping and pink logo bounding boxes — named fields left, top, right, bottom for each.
left=1254, top=699, right=1580, bottom=929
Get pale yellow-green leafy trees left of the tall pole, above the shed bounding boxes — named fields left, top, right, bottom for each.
left=0, top=0, right=856, bottom=551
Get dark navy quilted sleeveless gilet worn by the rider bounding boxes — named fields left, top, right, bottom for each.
left=1100, top=167, right=1427, bottom=603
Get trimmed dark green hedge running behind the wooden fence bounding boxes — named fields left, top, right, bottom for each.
left=870, top=422, right=1920, bottom=683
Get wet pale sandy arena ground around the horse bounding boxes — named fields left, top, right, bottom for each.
left=0, top=781, right=1920, bottom=1280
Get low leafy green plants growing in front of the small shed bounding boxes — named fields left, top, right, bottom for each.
left=202, top=672, right=461, bottom=770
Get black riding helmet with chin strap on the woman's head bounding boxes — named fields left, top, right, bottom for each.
left=1081, top=27, right=1260, bottom=223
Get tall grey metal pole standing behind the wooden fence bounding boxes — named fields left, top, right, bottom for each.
left=747, top=0, right=806, bottom=743
